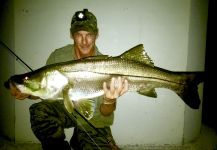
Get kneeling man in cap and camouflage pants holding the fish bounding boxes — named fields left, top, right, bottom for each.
left=10, top=9, right=128, bottom=150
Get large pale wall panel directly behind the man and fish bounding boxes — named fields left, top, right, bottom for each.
left=0, top=0, right=207, bottom=145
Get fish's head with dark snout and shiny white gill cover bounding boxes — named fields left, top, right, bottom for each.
left=5, top=70, right=68, bottom=99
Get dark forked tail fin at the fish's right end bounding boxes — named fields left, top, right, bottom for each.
left=176, top=72, right=204, bottom=109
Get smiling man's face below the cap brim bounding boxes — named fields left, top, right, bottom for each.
left=72, top=31, right=97, bottom=56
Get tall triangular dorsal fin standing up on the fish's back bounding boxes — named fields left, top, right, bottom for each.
left=119, top=44, right=154, bottom=66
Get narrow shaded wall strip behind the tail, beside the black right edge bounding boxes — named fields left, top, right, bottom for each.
left=183, top=0, right=208, bottom=142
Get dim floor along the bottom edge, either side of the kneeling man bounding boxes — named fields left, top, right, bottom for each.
left=0, top=125, right=217, bottom=150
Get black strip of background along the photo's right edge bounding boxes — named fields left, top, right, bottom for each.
left=202, top=0, right=217, bottom=133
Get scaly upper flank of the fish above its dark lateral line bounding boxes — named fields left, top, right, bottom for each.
left=60, top=58, right=188, bottom=84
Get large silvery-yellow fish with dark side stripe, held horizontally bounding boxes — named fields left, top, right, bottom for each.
left=5, top=44, right=203, bottom=116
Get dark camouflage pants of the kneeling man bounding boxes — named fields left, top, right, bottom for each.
left=29, top=101, right=118, bottom=150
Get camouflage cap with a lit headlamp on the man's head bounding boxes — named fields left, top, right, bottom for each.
left=70, top=9, right=98, bottom=34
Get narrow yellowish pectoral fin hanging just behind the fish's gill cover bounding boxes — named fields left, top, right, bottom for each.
left=63, top=85, right=74, bottom=113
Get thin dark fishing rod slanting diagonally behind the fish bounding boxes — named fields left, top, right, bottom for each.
left=0, top=40, right=117, bottom=150
